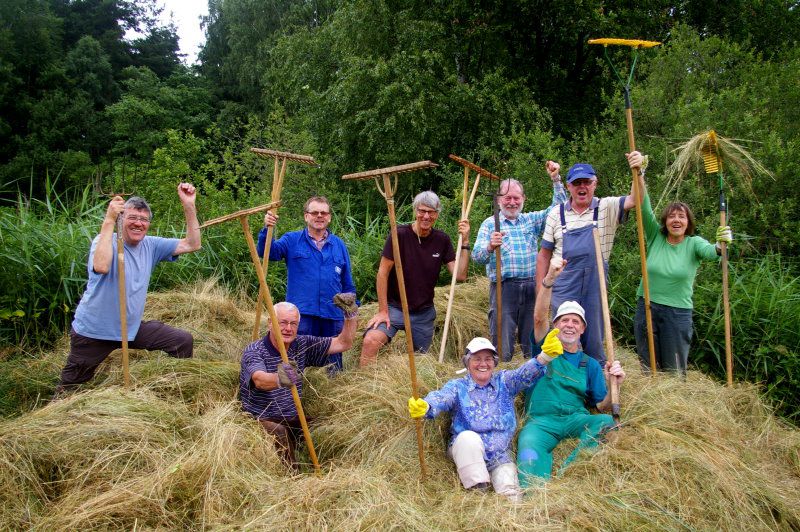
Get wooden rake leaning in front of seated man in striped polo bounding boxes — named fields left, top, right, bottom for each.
left=200, top=201, right=320, bottom=475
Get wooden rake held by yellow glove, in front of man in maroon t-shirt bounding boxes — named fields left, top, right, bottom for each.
left=342, top=161, right=438, bottom=480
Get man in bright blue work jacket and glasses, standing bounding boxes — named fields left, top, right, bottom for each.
left=257, top=196, right=356, bottom=373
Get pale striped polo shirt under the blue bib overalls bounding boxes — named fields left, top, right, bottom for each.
left=542, top=196, right=627, bottom=262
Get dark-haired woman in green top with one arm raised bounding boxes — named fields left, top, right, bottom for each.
left=628, top=152, right=733, bottom=375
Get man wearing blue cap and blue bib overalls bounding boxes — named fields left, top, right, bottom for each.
left=536, top=152, right=642, bottom=365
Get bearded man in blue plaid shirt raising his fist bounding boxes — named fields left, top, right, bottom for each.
left=472, top=161, right=567, bottom=361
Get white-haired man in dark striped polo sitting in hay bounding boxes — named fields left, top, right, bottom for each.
left=239, top=300, right=358, bottom=470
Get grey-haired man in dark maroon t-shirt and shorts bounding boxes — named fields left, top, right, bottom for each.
left=360, top=190, right=470, bottom=367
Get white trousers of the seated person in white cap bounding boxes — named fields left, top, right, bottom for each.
left=448, top=430, right=520, bottom=500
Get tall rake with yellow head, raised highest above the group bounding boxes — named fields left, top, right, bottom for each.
left=589, top=38, right=661, bottom=375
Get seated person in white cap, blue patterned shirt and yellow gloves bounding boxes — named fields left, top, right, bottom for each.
left=408, top=331, right=563, bottom=501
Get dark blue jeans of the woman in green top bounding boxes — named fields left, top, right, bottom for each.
left=633, top=297, right=692, bottom=375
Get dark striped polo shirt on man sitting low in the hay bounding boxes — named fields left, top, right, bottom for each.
left=239, top=333, right=333, bottom=419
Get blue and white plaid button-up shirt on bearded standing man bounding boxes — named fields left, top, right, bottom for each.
left=472, top=181, right=567, bottom=281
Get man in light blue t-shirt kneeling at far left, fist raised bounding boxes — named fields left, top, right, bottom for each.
left=56, top=183, right=200, bottom=396
